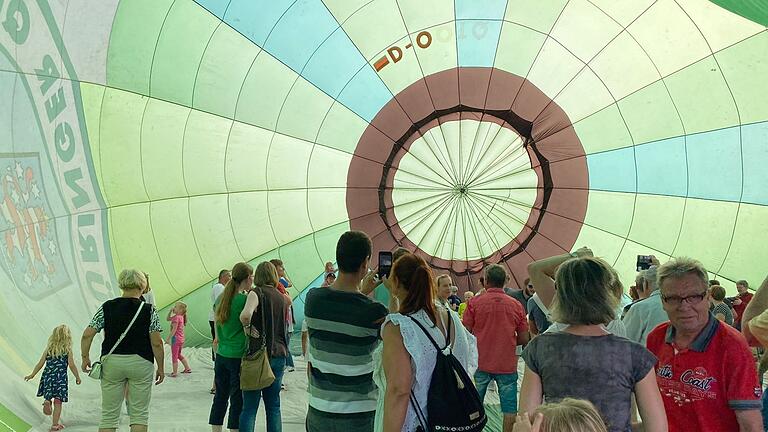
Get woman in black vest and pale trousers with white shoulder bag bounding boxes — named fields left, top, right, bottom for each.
left=80, top=269, right=165, bottom=432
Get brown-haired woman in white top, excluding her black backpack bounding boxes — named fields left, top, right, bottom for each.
left=373, top=254, right=477, bottom=432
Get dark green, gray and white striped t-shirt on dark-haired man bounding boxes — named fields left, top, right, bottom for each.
left=304, top=288, right=388, bottom=415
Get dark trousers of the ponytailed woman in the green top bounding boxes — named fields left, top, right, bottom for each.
left=208, top=355, right=243, bottom=429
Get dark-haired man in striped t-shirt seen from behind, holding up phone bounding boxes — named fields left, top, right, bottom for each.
left=304, top=231, right=387, bottom=432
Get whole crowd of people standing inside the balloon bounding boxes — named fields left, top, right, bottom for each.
left=21, top=231, right=768, bottom=432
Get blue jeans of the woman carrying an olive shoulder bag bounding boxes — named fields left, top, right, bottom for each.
left=240, top=357, right=285, bottom=432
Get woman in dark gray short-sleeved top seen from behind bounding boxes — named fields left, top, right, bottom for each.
left=520, top=257, right=667, bottom=432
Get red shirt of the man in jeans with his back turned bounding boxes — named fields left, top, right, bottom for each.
left=462, top=288, right=528, bottom=374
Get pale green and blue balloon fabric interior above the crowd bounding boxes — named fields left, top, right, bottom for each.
left=0, top=0, right=768, bottom=426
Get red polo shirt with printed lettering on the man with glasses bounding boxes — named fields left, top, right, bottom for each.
left=647, top=314, right=762, bottom=432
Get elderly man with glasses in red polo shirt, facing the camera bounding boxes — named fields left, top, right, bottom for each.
left=647, top=258, right=763, bottom=432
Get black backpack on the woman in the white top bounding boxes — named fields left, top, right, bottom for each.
left=408, top=312, right=488, bottom=432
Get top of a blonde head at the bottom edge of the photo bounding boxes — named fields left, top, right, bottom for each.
left=512, top=398, right=608, bottom=432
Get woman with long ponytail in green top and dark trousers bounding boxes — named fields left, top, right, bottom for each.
left=208, top=262, right=253, bottom=432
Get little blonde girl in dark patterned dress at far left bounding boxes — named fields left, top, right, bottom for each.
left=24, top=325, right=80, bottom=431
